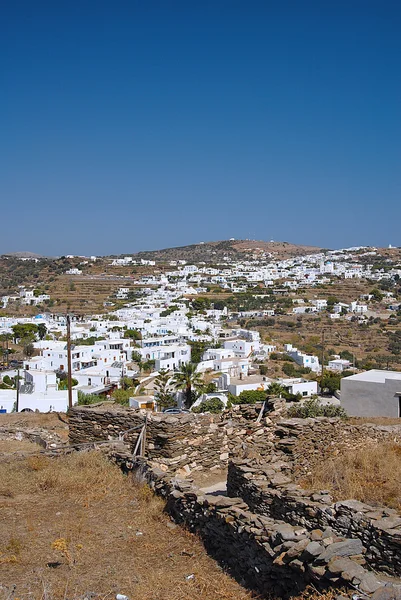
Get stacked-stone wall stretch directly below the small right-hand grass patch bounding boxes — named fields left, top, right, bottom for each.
left=227, top=454, right=401, bottom=576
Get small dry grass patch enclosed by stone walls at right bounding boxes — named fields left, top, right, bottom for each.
left=299, top=443, right=401, bottom=511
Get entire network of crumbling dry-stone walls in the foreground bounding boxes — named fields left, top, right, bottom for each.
left=69, top=404, right=401, bottom=600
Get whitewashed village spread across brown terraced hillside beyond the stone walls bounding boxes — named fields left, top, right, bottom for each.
left=0, top=241, right=401, bottom=417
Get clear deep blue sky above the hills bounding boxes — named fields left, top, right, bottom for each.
left=0, top=0, right=401, bottom=255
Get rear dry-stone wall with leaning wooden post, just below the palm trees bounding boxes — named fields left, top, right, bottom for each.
left=69, top=403, right=272, bottom=475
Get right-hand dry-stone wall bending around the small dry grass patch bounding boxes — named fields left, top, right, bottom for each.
left=227, top=419, right=401, bottom=576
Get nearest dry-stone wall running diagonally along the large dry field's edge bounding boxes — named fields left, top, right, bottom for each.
left=105, top=454, right=383, bottom=598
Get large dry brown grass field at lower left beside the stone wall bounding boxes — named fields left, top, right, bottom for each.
left=0, top=452, right=251, bottom=600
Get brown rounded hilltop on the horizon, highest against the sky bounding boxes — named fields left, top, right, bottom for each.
left=133, top=240, right=321, bottom=263
